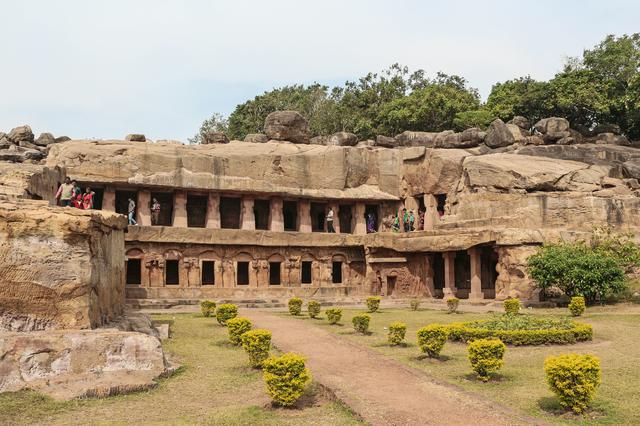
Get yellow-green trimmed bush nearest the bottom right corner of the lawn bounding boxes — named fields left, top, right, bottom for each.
left=544, top=354, right=600, bottom=413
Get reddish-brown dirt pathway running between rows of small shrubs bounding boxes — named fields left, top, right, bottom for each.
left=243, top=309, right=532, bottom=425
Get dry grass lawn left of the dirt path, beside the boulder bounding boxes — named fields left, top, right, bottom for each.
left=0, top=314, right=360, bottom=425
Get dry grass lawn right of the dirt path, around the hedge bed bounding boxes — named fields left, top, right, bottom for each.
left=300, top=305, right=640, bottom=425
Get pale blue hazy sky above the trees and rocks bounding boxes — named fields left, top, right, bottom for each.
left=0, top=0, right=640, bottom=140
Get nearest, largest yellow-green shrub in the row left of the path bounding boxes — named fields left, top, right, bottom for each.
left=262, top=353, right=311, bottom=407
